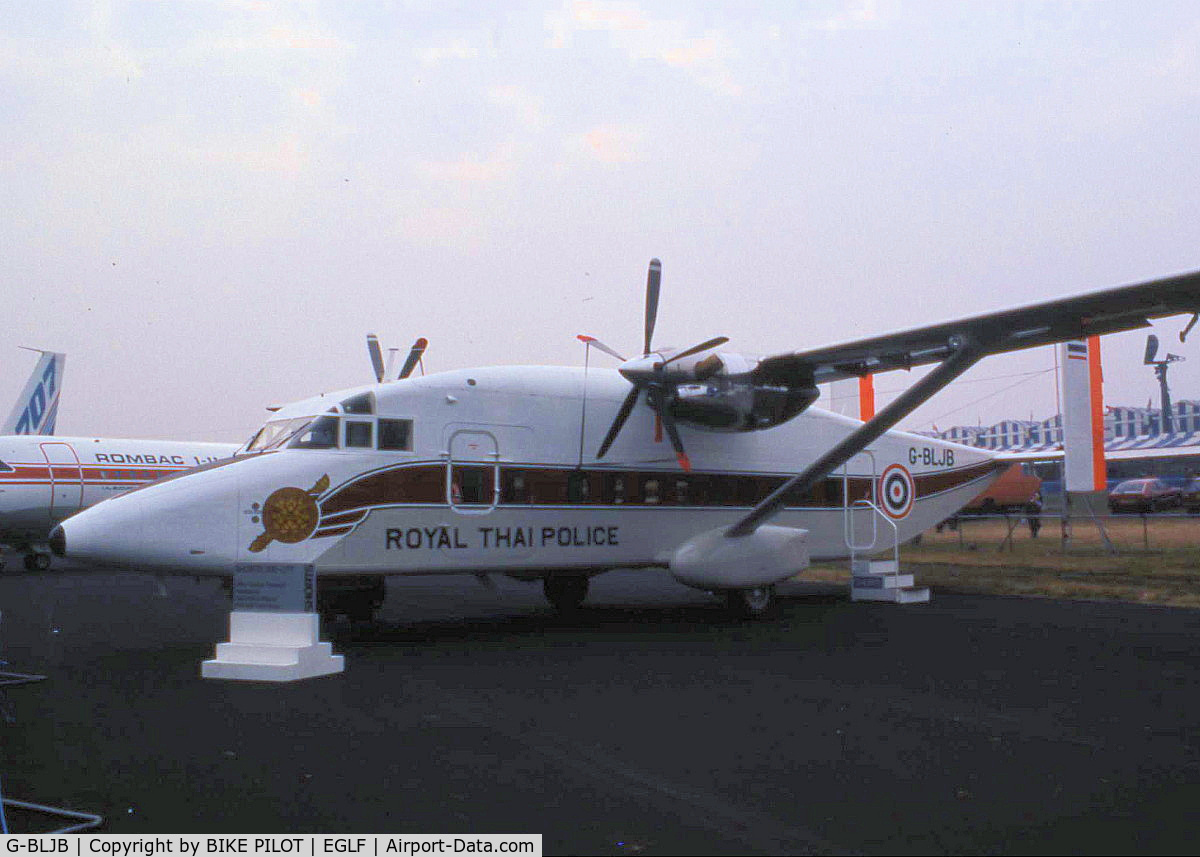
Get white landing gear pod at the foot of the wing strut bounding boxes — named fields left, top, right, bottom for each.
left=671, top=526, right=809, bottom=591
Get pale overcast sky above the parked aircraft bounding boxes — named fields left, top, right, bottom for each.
left=0, top=0, right=1200, bottom=441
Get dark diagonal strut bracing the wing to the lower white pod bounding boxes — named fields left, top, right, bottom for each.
left=725, top=336, right=988, bottom=539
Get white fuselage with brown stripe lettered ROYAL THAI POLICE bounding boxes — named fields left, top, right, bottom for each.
left=51, top=366, right=998, bottom=579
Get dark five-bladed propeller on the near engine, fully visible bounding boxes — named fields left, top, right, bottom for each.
left=577, top=259, right=730, bottom=471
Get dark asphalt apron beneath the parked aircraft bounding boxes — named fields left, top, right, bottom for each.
left=0, top=556, right=1200, bottom=855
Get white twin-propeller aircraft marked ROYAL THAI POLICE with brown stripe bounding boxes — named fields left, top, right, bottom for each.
left=50, top=259, right=1200, bottom=617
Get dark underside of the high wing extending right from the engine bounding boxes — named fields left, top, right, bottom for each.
left=751, top=271, right=1200, bottom=385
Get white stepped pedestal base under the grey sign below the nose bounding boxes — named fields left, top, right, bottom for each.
left=200, top=610, right=346, bottom=682
